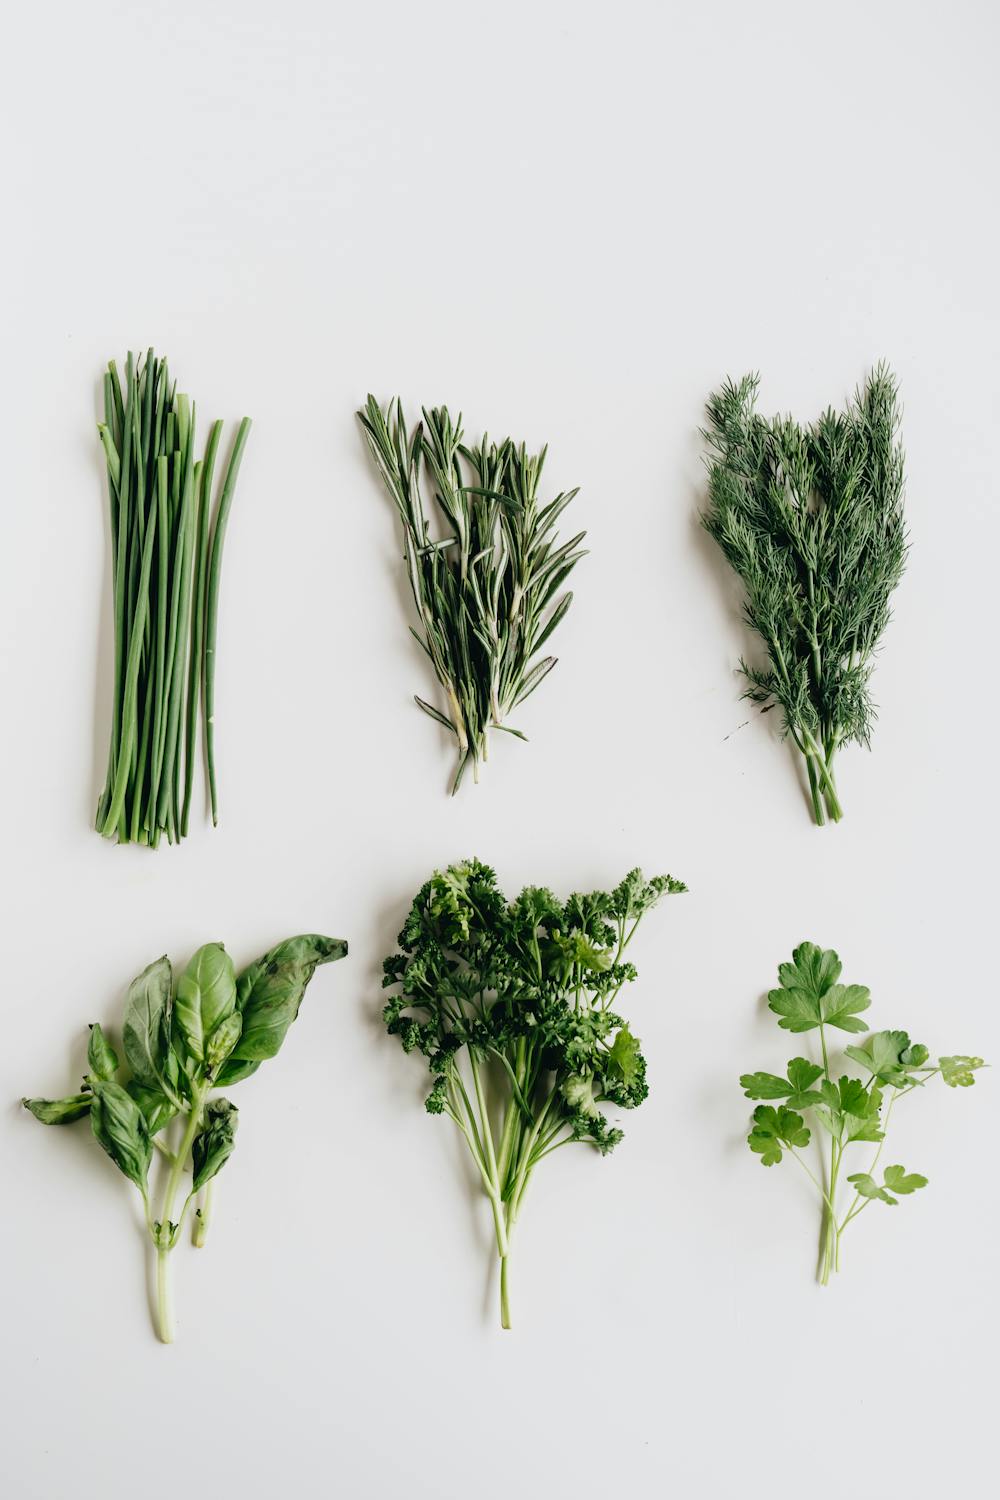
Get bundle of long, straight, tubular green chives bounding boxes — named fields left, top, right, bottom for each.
left=97, top=350, right=250, bottom=848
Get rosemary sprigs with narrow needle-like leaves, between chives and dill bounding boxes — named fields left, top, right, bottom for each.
left=358, top=396, right=586, bottom=792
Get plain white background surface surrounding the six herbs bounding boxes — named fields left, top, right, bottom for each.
left=0, top=0, right=1000, bottom=1500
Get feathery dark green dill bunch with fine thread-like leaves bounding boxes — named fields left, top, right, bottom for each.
left=703, top=366, right=907, bottom=824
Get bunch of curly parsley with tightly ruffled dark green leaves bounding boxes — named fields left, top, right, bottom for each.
left=382, top=860, right=685, bottom=1328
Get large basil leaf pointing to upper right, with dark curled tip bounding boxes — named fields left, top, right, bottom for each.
left=224, top=933, right=348, bottom=1085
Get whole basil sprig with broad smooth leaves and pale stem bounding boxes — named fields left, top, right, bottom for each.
left=24, top=933, right=348, bottom=1344
